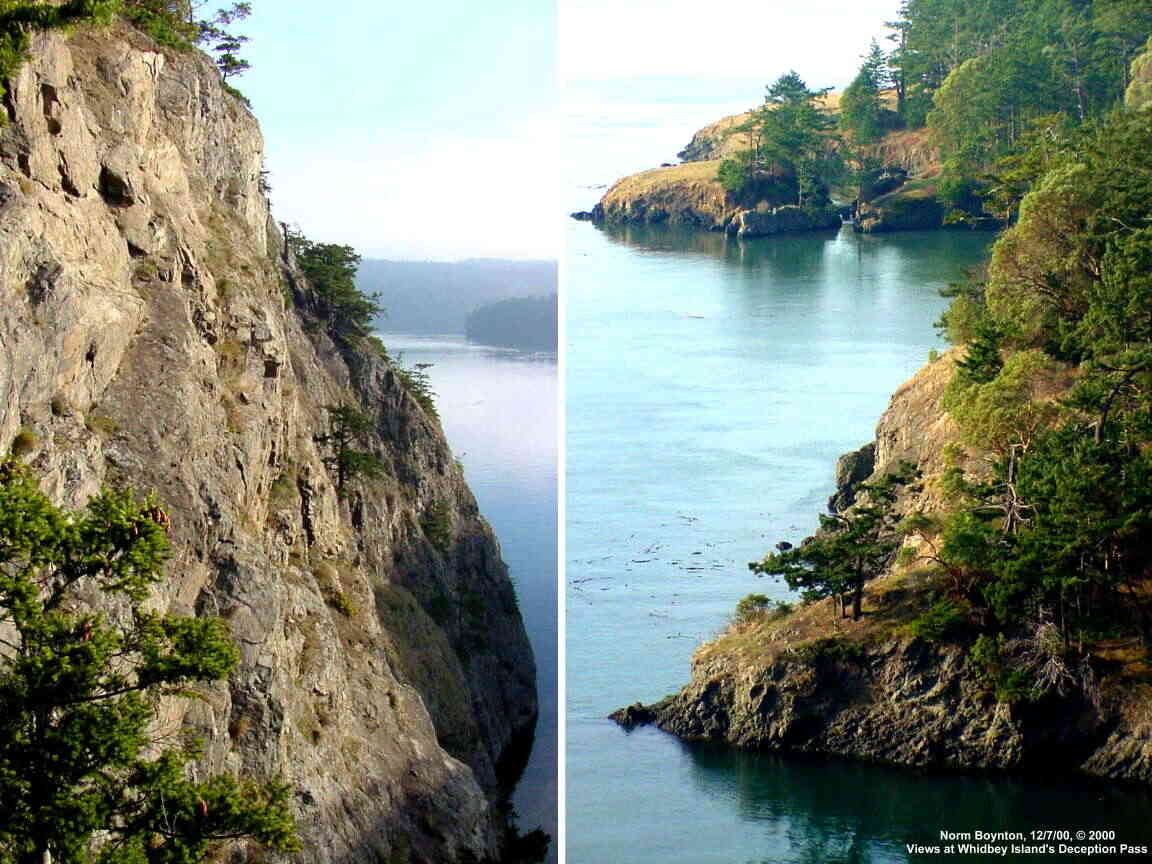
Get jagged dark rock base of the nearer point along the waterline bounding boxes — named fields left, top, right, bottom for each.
left=612, top=638, right=1152, bottom=783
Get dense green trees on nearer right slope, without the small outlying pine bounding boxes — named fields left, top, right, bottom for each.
left=934, top=112, right=1152, bottom=655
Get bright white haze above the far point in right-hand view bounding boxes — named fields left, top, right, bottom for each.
left=559, top=0, right=900, bottom=210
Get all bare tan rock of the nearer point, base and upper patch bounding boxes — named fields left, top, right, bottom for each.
left=613, top=351, right=1152, bottom=782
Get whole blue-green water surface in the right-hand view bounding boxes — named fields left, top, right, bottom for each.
left=566, top=223, right=1152, bottom=864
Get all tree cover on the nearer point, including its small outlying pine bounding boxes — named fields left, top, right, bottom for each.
left=745, top=82, right=1152, bottom=704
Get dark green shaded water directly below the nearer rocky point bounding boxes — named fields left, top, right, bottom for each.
left=681, top=743, right=1152, bottom=864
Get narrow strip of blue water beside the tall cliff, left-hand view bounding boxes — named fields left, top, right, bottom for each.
left=380, top=333, right=558, bottom=862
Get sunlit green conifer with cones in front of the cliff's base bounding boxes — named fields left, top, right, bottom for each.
left=0, top=461, right=298, bottom=864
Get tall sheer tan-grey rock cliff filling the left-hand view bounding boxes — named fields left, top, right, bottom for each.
left=0, top=26, right=536, bottom=863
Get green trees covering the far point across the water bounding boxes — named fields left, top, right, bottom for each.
left=718, top=0, right=1152, bottom=222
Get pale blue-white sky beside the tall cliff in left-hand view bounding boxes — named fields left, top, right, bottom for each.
left=240, top=0, right=559, bottom=259
